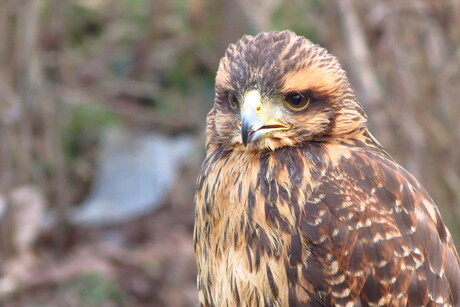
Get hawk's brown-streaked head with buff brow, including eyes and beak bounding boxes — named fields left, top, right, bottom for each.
left=207, top=31, right=366, bottom=150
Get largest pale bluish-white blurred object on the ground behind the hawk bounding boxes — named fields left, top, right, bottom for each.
left=71, top=128, right=194, bottom=226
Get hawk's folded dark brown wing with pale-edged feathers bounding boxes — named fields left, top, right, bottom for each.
left=301, top=151, right=460, bottom=305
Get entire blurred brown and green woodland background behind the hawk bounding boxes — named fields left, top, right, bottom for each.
left=0, top=0, right=460, bottom=306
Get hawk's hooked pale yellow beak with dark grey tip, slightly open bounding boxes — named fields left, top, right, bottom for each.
left=241, top=90, right=290, bottom=147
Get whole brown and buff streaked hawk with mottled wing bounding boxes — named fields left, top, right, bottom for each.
left=194, top=31, right=460, bottom=306
